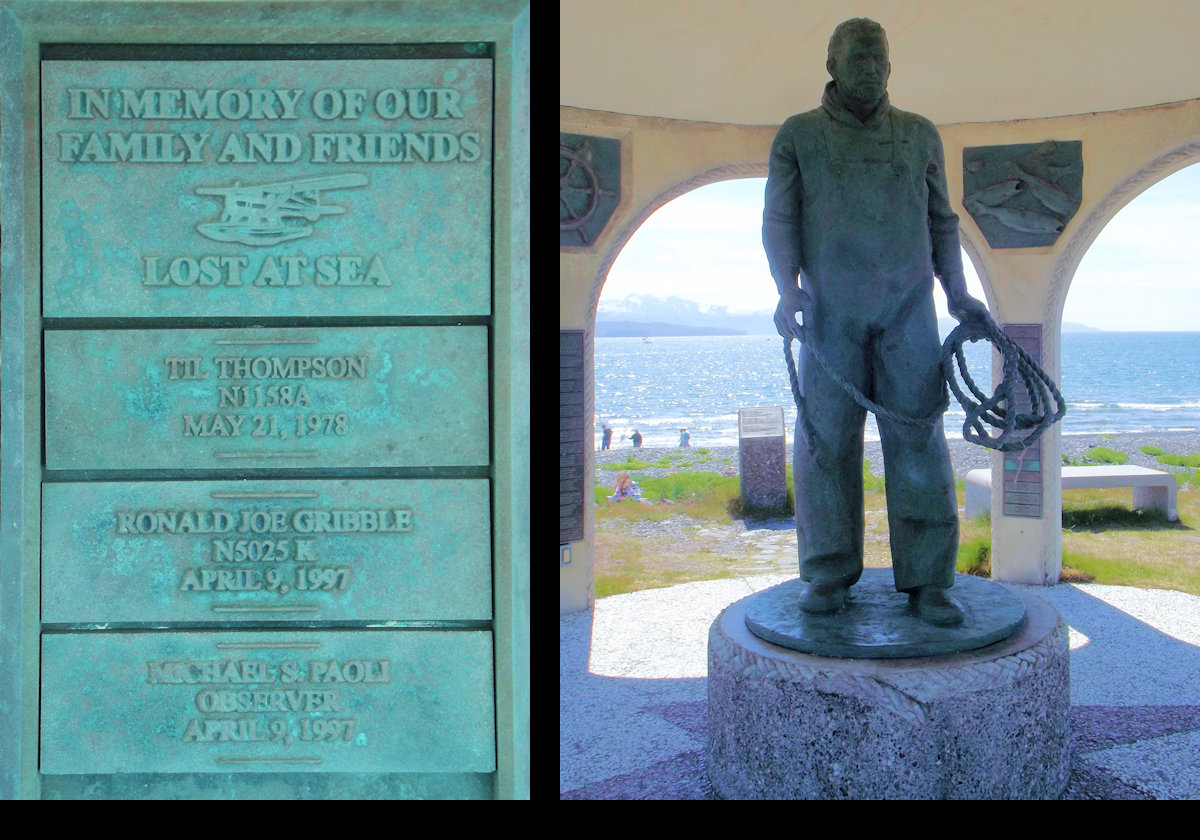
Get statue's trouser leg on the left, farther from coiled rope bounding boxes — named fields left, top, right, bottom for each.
left=792, top=338, right=866, bottom=586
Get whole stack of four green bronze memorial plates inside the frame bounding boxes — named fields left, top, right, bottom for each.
left=30, top=44, right=497, bottom=791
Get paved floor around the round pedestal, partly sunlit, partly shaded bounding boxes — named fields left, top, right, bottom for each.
left=559, top=578, right=1200, bottom=799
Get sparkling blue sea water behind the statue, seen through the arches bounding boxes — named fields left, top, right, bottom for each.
left=595, top=332, right=1200, bottom=449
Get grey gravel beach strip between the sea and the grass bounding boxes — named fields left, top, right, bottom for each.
left=595, top=432, right=1200, bottom=487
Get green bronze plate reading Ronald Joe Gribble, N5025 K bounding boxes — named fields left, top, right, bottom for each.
left=42, top=480, right=492, bottom=625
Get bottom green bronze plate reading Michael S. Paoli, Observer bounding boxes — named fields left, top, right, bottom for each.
left=41, top=630, right=496, bottom=774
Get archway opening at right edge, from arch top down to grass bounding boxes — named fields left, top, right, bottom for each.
left=1060, top=157, right=1200, bottom=593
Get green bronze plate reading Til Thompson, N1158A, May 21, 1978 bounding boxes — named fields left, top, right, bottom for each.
left=46, top=326, right=488, bottom=469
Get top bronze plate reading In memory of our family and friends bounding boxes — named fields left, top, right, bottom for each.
left=42, top=59, right=492, bottom=318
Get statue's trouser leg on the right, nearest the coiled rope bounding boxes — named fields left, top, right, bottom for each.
left=872, top=300, right=959, bottom=592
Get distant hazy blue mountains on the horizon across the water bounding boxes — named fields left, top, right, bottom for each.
left=596, top=295, right=1103, bottom=338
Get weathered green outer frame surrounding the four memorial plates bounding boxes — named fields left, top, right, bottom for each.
left=0, top=0, right=529, bottom=799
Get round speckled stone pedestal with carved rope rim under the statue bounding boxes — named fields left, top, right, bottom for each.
left=708, top=593, right=1070, bottom=799
